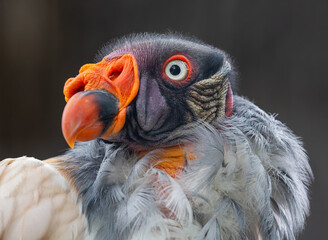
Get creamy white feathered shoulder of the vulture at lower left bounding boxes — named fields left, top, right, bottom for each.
left=0, top=157, right=85, bottom=240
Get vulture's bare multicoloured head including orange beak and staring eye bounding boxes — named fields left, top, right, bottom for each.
left=62, top=34, right=234, bottom=149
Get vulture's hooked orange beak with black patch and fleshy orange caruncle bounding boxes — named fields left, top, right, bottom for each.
left=62, top=54, right=139, bottom=148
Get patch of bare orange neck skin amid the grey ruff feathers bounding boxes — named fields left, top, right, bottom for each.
left=140, top=146, right=197, bottom=178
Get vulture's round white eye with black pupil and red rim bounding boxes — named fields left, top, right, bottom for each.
left=163, top=55, right=191, bottom=82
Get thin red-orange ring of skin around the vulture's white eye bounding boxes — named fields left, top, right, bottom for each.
left=162, top=54, right=192, bottom=84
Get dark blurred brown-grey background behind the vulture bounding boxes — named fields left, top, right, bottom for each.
left=0, top=0, right=328, bottom=239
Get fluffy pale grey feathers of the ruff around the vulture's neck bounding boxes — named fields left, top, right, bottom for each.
left=59, top=32, right=312, bottom=240
